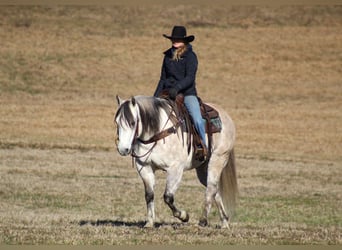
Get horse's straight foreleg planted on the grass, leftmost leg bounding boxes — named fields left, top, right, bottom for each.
left=137, top=166, right=155, bottom=227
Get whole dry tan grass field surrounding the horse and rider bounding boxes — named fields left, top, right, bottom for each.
left=0, top=4, right=342, bottom=245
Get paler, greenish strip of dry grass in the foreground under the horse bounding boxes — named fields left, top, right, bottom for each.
left=0, top=148, right=342, bottom=245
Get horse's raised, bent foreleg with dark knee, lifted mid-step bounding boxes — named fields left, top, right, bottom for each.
left=164, top=169, right=189, bottom=222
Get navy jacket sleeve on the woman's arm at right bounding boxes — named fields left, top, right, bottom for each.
left=176, top=53, right=198, bottom=91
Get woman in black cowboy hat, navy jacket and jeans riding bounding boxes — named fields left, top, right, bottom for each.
left=154, top=26, right=207, bottom=157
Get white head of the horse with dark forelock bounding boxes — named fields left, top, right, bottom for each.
left=115, top=96, right=139, bottom=156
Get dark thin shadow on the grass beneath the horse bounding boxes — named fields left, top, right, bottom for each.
left=78, top=220, right=184, bottom=228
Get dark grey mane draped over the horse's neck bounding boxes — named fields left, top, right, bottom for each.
left=135, top=96, right=172, bottom=134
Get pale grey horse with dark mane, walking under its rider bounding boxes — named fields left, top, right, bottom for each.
left=114, top=96, right=238, bottom=228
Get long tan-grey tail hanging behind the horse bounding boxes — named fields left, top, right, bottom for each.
left=219, top=149, right=239, bottom=217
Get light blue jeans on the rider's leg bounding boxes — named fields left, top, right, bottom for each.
left=184, top=95, right=207, bottom=146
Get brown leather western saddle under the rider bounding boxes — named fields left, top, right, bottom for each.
left=160, top=92, right=222, bottom=161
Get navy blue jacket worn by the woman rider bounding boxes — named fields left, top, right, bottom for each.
left=154, top=44, right=198, bottom=96
